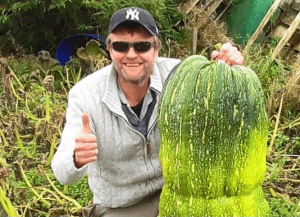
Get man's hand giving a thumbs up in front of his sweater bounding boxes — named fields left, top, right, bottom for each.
left=75, top=113, right=98, bottom=168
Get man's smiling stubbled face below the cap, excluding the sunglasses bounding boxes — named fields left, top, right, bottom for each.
left=108, top=27, right=159, bottom=86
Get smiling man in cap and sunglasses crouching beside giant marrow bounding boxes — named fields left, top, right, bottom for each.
left=52, top=7, right=244, bottom=216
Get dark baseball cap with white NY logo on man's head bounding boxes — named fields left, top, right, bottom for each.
left=108, top=7, right=159, bottom=36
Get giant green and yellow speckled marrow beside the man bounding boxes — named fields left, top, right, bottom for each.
left=158, top=55, right=270, bottom=217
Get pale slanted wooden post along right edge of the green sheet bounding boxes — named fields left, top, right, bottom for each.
left=244, top=0, right=282, bottom=52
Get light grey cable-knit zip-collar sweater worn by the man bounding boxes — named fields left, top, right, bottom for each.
left=51, top=57, right=180, bottom=208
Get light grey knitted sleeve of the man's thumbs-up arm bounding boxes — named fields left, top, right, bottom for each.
left=51, top=85, right=92, bottom=185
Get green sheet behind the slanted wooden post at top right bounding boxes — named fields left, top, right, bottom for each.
left=222, top=0, right=275, bottom=44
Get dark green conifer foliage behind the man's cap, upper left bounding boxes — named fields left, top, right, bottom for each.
left=0, top=0, right=184, bottom=56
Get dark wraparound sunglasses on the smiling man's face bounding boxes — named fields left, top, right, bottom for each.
left=112, top=41, right=153, bottom=53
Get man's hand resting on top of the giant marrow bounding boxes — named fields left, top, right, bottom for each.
left=211, top=42, right=245, bottom=66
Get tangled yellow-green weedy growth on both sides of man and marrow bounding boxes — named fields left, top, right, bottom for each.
left=0, top=23, right=300, bottom=216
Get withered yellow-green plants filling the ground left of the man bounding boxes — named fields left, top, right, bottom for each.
left=0, top=52, right=108, bottom=216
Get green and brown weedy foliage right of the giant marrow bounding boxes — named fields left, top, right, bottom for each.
left=245, top=38, right=300, bottom=216
